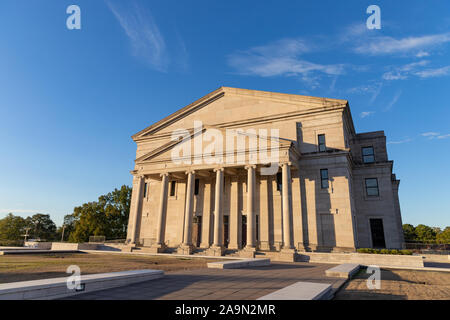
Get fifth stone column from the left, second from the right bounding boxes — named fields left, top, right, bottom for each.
left=241, top=165, right=256, bottom=258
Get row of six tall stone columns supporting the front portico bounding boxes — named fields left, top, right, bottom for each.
left=132, top=163, right=293, bottom=254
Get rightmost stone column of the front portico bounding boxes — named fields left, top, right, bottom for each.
left=280, top=162, right=295, bottom=261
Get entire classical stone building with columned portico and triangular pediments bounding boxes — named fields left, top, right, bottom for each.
left=127, top=87, right=404, bottom=256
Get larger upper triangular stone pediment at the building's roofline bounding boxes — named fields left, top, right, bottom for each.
left=132, top=87, right=347, bottom=141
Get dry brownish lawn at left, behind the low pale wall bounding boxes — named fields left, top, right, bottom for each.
left=0, top=253, right=216, bottom=283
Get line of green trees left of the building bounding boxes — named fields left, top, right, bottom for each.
left=0, top=185, right=131, bottom=246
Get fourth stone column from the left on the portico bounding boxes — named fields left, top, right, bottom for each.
left=208, top=168, right=224, bottom=256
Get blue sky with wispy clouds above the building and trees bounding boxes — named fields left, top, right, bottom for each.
left=0, top=0, right=450, bottom=227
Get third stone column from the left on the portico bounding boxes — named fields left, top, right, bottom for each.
left=178, top=171, right=195, bottom=254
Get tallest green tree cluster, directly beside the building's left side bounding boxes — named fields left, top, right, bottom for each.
left=69, top=185, right=131, bottom=242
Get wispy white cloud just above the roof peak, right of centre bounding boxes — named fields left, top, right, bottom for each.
left=228, top=39, right=345, bottom=86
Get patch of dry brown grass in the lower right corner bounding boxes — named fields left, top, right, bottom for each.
left=335, top=269, right=450, bottom=300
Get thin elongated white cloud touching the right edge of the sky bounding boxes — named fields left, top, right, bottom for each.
left=354, top=33, right=450, bottom=55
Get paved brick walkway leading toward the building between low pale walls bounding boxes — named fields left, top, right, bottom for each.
left=67, top=262, right=345, bottom=300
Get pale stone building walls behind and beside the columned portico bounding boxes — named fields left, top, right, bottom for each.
left=129, top=89, right=403, bottom=250
